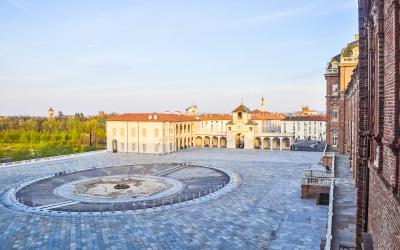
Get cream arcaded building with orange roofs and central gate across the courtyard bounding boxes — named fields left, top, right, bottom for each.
left=107, top=101, right=294, bottom=154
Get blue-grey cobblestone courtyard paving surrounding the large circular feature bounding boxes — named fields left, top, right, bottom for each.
left=0, top=149, right=328, bottom=249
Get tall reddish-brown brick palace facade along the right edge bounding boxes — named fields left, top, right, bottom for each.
left=325, top=0, right=400, bottom=249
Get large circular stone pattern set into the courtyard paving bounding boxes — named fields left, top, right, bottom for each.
left=7, top=163, right=233, bottom=214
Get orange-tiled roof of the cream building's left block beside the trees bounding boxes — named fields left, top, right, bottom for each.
left=107, top=113, right=197, bottom=122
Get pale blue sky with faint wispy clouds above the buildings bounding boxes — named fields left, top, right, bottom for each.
left=0, top=0, right=357, bottom=115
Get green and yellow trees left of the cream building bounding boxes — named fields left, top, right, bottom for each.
left=0, top=114, right=107, bottom=161
